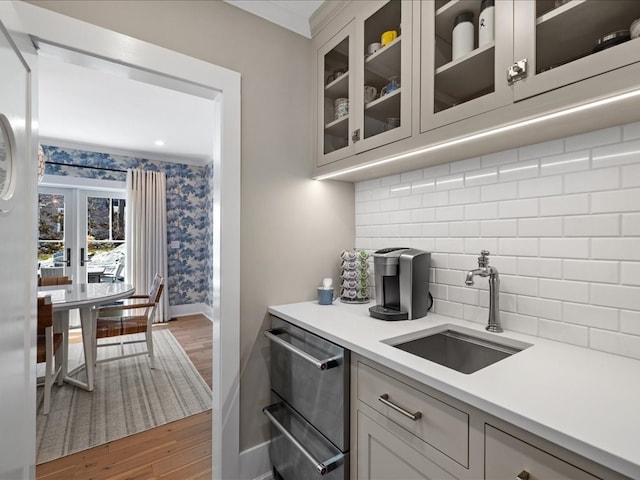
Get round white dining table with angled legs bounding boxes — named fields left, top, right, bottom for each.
left=38, top=283, right=135, bottom=392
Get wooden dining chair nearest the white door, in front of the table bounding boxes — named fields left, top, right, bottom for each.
left=37, top=295, right=66, bottom=415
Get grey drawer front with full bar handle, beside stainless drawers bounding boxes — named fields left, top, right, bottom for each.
left=358, top=363, right=469, bottom=468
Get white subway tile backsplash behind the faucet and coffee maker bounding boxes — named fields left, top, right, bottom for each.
left=356, top=122, right=640, bottom=358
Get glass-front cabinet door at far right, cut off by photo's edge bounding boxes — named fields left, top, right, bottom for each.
left=513, top=0, right=640, bottom=101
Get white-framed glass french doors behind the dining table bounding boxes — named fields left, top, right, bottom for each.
left=38, top=187, right=126, bottom=283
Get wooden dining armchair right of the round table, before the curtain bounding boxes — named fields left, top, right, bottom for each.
left=93, top=274, right=164, bottom=368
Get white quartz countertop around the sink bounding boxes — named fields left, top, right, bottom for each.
left=268, top=301, right=640, bottom=478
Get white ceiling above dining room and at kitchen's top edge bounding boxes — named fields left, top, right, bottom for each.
left=39, top=0, right=322, bottom=165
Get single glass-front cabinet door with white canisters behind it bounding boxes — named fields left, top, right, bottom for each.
left=420, top=0, right=518, bottom=132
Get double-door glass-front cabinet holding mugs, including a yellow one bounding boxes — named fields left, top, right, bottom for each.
left=314, top=0, right=412, bottom=166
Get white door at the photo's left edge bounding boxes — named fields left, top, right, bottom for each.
left=0, top=16, right=37, bottom=480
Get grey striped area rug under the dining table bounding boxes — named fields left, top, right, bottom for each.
left=36, top=330, right=212, bottom=464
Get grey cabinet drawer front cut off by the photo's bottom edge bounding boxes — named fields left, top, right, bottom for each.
left=485, top=425, right=598, bottom=480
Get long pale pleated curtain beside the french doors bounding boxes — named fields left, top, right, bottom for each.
left=125, top=169, right=169, bottom=322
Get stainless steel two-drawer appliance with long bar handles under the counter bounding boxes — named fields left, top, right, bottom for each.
left=263, top=317, right=350, bottom=480
